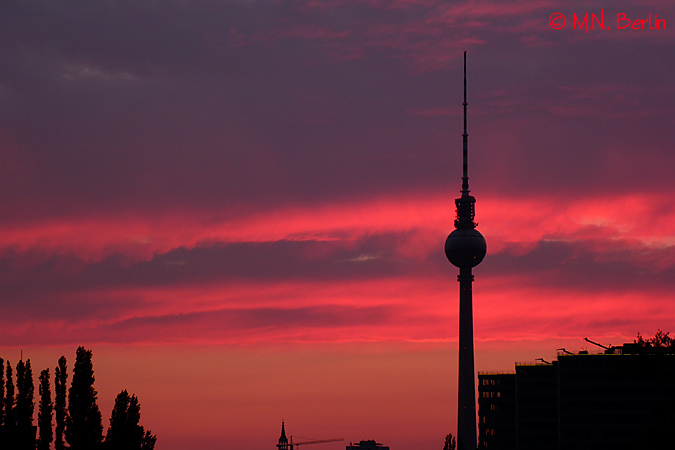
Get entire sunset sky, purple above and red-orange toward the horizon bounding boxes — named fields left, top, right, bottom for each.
left=0, top=0, right=675, bottom=450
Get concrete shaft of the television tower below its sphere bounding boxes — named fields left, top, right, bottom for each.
left=457, top=267, right=477, bottom=450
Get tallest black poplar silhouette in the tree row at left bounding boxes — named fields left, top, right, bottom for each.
left=65, top=347, right=103, bottom=450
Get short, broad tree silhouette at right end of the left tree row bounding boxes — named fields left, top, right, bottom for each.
left=105, top=390, right=157, bottom=450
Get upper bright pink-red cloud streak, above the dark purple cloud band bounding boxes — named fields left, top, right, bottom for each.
left=0, top=193, right=675, bottom=270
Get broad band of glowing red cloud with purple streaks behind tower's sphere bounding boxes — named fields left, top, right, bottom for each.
left=2, top=190, right=675, bottom=345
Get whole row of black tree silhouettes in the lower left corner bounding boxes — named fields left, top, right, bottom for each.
left=0, top=347, right=157, bottom=450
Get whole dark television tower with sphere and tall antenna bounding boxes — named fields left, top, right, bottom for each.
left=445, top=52, right=487, bottom=450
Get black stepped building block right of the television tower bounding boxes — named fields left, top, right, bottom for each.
left=478, top=344, right=675, bottom=450
